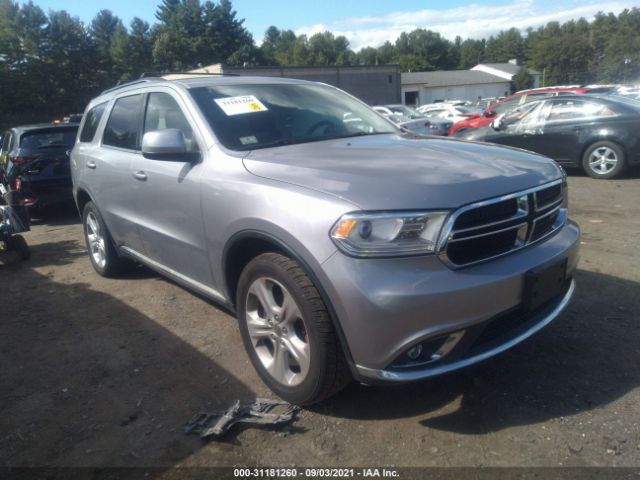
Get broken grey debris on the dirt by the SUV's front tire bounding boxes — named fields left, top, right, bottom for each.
left=184, top=398, right=299, bottom=439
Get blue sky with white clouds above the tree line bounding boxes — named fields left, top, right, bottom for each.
left=20, top=0, right=640, bottom=50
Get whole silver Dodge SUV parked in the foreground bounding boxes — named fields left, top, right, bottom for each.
left=72, top=76, right=580, bottom=404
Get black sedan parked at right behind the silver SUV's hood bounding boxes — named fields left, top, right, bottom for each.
left=454, top=91, right=640, bottom=179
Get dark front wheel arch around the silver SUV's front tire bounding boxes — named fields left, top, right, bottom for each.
left=221, top=230, right=358, bottom=378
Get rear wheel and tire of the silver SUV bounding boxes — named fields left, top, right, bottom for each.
left=82, top=202, right=133, bottom=277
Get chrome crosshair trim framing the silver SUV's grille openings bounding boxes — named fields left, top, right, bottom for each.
left=436, top=179, right=568, bottom=269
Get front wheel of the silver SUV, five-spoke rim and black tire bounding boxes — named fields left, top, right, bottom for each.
left=236, top=253, right=351, bottom=405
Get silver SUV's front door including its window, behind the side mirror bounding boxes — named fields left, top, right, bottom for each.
left=130, top=89, right=212, bottom=285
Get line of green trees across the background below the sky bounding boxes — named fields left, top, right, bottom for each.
left=0, top=0, right=640, bottom=128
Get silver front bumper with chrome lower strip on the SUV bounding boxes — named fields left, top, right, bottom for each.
left=321, top=221, right=580, bottom=382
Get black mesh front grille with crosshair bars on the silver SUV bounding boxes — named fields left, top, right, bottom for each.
left=440, top=180, right=566, bottom=267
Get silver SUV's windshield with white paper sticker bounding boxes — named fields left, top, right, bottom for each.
left=191, top=84, right=398, bottom=150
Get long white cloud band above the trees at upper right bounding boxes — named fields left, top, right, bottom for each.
left=295, top=0, right=636, bottom=50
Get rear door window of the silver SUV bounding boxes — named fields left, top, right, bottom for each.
left=102, top=95, right=142, bottom=150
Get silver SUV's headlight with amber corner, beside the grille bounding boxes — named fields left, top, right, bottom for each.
left=331, top=212, right=448, bottom=257
